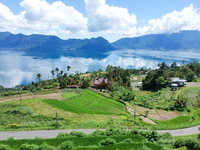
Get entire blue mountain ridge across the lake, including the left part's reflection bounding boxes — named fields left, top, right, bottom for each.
left=0, top=30, right=200, bottom=59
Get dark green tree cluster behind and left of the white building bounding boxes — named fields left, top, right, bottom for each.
left=142, top=60, right=200, bottom=91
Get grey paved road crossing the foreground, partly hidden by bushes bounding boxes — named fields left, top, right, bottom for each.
left=0, top=125, right=200, bottom=140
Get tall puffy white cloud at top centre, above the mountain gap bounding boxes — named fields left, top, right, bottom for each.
left=84, top=0, right=137, bottom=34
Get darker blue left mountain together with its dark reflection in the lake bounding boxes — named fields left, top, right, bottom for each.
left=0, top=32, right=116, bottom=58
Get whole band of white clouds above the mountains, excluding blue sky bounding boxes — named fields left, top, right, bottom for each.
left=0, top=0, right=200, bottom=37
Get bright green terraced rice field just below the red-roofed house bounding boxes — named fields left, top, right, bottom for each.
left=44, top=90, right=128, bottom=115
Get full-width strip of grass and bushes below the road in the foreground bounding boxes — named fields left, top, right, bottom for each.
left=0, top=128, right=200, bottom=150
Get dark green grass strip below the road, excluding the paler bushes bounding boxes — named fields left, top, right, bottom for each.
left=0, top=135, right=162, bottom=150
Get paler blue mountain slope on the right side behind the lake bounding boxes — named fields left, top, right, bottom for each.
left=112, top=31, right=200, bottom=50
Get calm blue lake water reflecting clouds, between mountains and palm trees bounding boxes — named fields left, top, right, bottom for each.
left=0, top=50, right=200, bottom=87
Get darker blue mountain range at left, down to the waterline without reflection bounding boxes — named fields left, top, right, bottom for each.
left=0, top=32, right=115, bottom=52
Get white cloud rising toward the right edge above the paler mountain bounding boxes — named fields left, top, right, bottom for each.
left=134, top=4, right=200, bottom=36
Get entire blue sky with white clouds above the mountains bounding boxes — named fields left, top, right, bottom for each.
left=0, top=0, right=200, bottom=42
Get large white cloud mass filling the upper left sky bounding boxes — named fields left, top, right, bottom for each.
left=0, top=0, right=88, bottom=33
